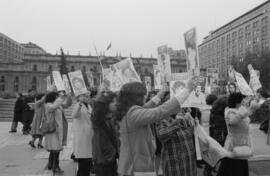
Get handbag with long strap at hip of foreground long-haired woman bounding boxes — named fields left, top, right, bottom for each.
left=126, top=117, right=155, bottom=172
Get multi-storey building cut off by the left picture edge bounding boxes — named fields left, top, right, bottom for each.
left=0, top=32, right=24, bottom=64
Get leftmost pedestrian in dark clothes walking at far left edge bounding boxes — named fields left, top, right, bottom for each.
left=9, top=93, right=24, bottom=133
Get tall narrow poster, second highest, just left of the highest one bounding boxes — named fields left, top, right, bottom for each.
left=157, top=45, right=171, bottom=84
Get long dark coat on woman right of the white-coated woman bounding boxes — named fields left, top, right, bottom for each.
left=91, top=96, right=118, bottom=165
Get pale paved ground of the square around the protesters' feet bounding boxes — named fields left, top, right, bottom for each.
left=0, top=122, right=270, bottom=176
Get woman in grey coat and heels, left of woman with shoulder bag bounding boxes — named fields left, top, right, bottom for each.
left=29, top=94, right=45, bottom=148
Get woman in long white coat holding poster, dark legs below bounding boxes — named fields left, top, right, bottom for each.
left=71, top=93, right=93, bottom=176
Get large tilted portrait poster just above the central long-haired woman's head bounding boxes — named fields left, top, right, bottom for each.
left=111, top=58, right=142, bottom=84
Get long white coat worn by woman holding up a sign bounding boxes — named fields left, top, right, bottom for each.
left=72, top=103, right=93, bottom=158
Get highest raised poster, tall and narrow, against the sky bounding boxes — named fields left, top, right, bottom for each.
left=184, top=28, right=199, bottom=75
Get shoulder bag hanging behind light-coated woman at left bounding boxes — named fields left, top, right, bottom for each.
left=40, top=110, right=56, bottom=134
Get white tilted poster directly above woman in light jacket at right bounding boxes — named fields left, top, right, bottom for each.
left=234, top=71, right=254, bottom=96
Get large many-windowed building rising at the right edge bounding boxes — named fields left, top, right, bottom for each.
left=198, top=0, right=270, bottom=78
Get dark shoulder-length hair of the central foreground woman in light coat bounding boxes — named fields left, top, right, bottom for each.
left=116, top=82, right=147, bottom=120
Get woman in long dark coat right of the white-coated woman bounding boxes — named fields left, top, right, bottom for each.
left=91, top=91, right=118, bottom=176
